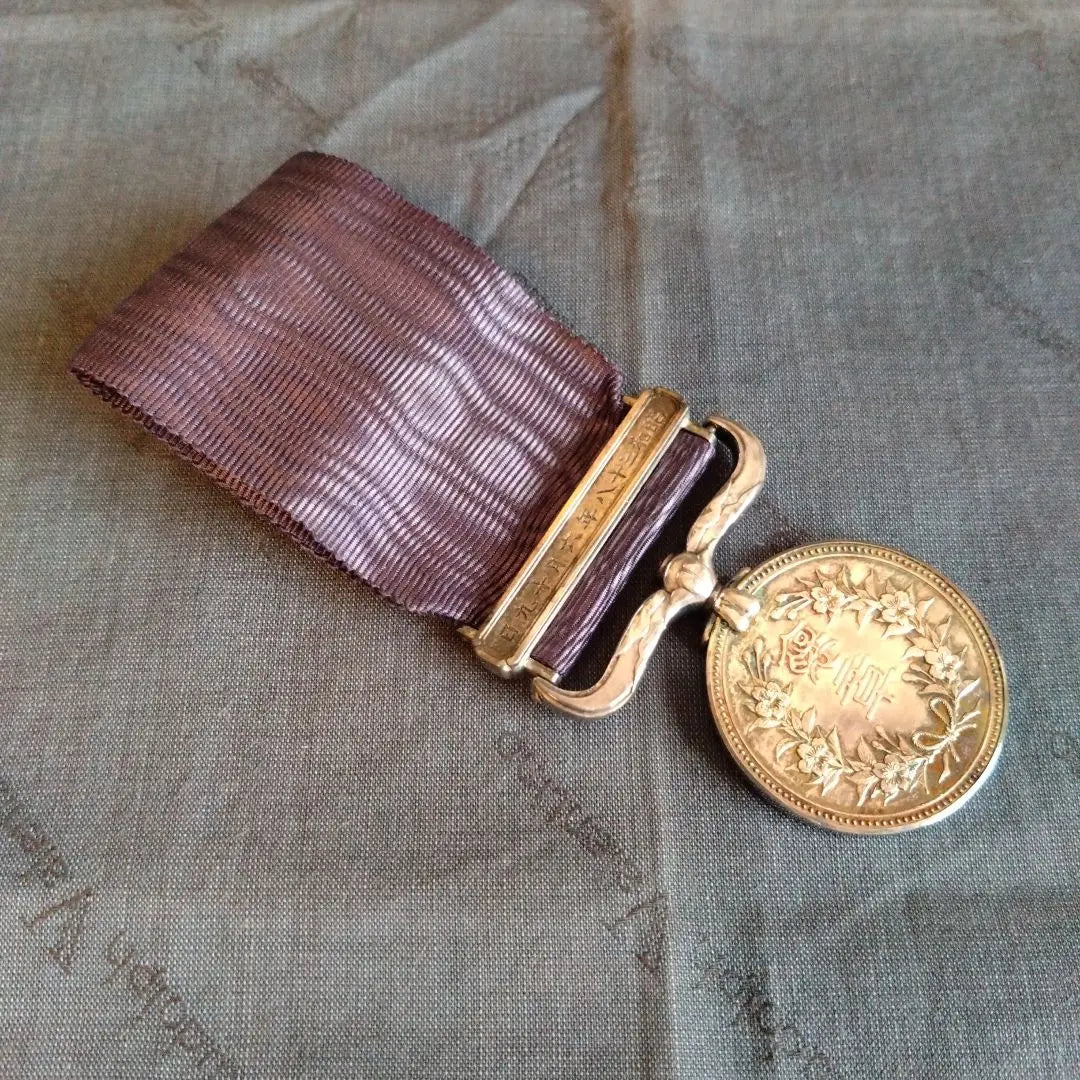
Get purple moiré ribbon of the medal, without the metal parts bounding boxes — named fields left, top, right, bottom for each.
left=71, top=152, right=712, bottom=671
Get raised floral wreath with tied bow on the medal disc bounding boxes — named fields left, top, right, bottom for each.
left=738, top=564, right=980, bottom=806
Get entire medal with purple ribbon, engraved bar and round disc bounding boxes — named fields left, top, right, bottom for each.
left=71, top=153, right=1005, bottom=833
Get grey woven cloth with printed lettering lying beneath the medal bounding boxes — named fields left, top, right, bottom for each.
left=0, top=0, right=1080, bottom=1080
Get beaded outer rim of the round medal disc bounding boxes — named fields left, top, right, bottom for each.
left=705, top=540, right=1009, bottom=836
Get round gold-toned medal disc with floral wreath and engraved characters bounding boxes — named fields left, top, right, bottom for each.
left=706, top=541, right=1007, bottom=833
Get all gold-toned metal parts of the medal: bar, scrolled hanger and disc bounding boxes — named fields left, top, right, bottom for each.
left=481, top=401, right=1007, bottom=833
